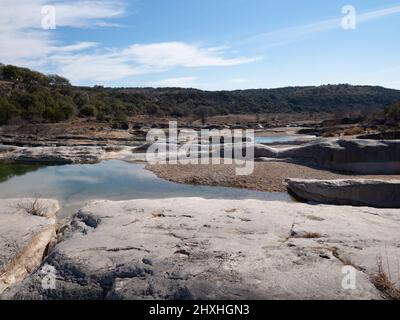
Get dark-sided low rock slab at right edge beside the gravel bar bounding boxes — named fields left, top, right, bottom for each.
left=287, top=179, right=400, bottom=208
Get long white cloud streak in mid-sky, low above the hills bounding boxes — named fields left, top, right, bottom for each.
left=50, top=42, right=259, bottom=85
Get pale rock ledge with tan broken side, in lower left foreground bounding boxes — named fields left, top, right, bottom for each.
left=0, top=199, right=59, bottom=293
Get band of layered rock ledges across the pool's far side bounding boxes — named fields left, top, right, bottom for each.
left=0, top=139, right=400, bottom=174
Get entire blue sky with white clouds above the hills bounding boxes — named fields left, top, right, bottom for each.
left=0, top=0, right=400, bottom=90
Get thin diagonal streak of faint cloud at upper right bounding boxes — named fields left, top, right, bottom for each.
left=245, top=5, right=400, bottom=48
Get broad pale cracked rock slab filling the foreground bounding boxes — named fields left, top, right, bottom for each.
left=3, top=198, right=400, bottom=299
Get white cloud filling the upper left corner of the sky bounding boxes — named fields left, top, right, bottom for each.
left=0, top=0, right=123, bottom=67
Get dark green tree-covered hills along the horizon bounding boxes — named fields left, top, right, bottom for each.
left=0, top=65, right=400, bottom=127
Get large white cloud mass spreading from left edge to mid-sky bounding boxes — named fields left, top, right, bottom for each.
left=0, top=0, right=258, bottom=85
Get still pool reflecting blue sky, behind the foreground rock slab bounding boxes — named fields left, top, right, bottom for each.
left=0, top=161, right=290, bottom=217
